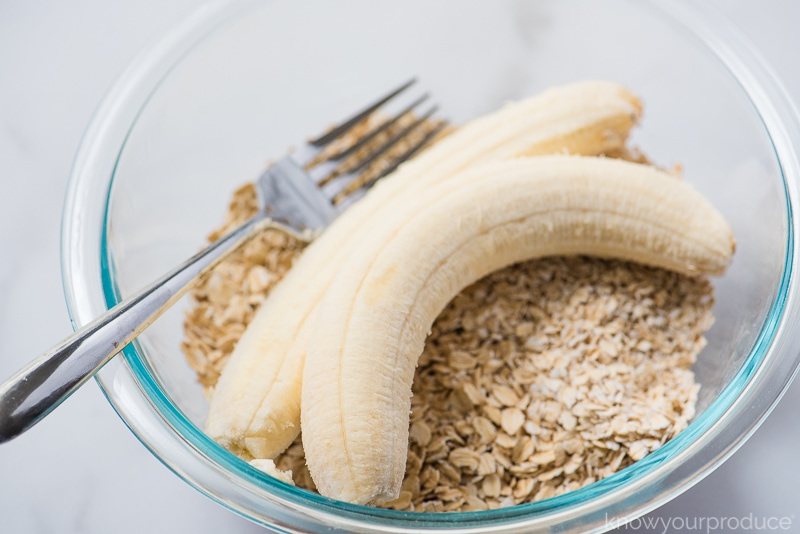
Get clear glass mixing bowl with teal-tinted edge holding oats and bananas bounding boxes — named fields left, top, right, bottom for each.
left=62, top=0, right=800, bottom=532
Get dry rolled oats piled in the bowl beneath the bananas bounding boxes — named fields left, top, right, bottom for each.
left=182, top=185, right=713, bottom=512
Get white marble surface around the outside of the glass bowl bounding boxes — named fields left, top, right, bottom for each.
left=0, top=0, right=800, bottom=534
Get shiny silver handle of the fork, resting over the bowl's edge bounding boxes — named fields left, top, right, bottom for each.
left=0, top=214, right=276, bottom=443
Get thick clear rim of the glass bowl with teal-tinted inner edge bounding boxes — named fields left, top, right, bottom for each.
left=61, top=0, right=800, bottom=532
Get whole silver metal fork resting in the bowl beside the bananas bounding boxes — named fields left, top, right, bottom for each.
left=0, top=80, right=446, bottom=443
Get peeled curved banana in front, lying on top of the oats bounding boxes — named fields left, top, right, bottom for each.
left=301, top=156, right=735, bottom=504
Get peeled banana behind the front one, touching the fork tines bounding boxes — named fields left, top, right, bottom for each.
left=206, top=82, right=641, bottom=460
